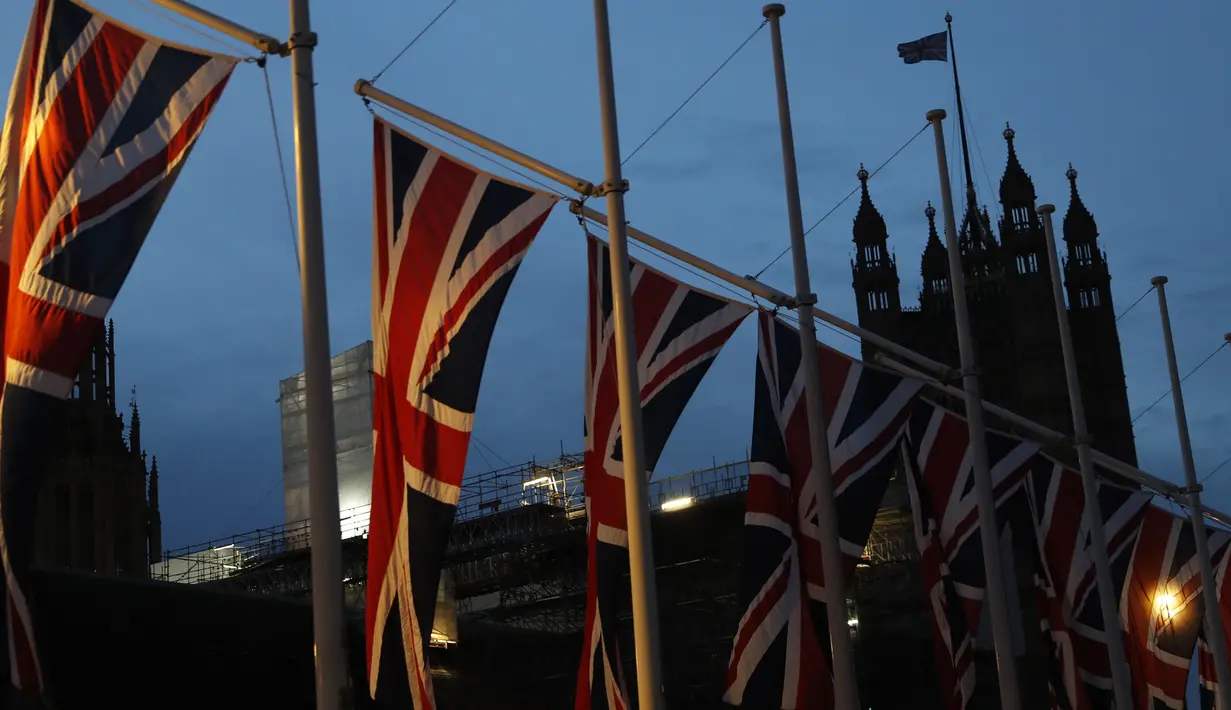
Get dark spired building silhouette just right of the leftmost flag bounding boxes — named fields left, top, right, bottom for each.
left=34, top=321, right=162, bottom=577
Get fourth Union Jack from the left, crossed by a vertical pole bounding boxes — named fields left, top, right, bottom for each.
left=724, top=310, right=923, bottom=709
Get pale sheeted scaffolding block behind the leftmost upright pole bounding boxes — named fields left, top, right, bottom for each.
left=278, top=341, right=373, bottom=524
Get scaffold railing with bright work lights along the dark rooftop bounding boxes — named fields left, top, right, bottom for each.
left=150, top=454, right=748, bottom=583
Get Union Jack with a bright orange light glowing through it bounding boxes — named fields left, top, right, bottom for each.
left=1120, top=506, right=1231, bottom=710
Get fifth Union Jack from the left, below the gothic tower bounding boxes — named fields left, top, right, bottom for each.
left=905, top=401, right=1039, bottom=710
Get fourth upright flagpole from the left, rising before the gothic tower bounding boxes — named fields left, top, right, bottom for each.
left=927, top=108, right=1022, bottom=710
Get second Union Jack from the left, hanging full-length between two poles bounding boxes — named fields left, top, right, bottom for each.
left=366, top=118, right=556, bottom=710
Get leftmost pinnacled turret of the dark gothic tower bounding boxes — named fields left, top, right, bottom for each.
left=851, top=165, right=901, bottom=358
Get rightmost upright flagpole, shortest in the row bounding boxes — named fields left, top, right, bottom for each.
left=1150, top=276, right=1231, bottom=710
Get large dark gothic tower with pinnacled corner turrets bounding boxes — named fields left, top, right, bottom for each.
left=851, top=126, right=1136, bottom=464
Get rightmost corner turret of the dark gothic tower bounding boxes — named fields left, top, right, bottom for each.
left=1064, top=164, right=1137, bottom=465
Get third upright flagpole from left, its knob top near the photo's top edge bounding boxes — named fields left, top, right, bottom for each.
left=761, top=2, right=859, bottom=710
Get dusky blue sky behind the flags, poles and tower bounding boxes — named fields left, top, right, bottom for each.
left=0, top=0, right=1231, bottom=556
